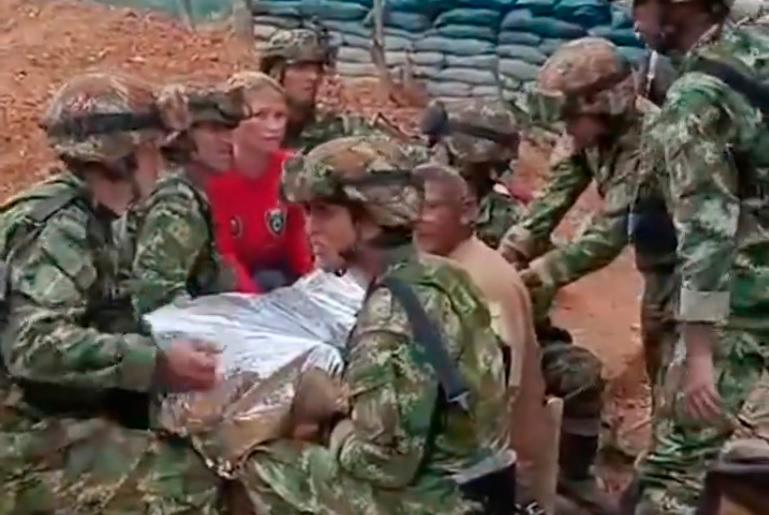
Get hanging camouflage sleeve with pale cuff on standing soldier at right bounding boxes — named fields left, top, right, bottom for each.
left=650, top=74, right=759, bottom=323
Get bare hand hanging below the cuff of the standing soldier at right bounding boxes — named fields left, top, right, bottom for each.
left=684, top=354, right=723, bottom=423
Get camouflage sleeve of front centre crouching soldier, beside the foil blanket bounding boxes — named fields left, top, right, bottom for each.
left=332, top=290, right=438, bottom=488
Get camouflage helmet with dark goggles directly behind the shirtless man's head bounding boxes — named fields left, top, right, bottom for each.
left=422, top=100, right=520, bottom=165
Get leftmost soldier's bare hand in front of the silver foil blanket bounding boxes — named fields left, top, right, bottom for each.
left=156, top=340, right=219, bottom=392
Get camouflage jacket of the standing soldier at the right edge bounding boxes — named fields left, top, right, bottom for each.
left=644, top=25, right=769, bottom=329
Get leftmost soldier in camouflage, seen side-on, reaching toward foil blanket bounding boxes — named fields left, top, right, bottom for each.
left=0, top=74, right=221, bottom=515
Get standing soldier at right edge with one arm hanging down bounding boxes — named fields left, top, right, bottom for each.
left=636, top=0, right=769, bottom=514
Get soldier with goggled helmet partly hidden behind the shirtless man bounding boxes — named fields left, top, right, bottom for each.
left=422, top=100, right=524, bottom=249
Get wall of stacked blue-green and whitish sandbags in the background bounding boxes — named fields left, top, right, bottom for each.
left=251, top=0, right=644, bottom=99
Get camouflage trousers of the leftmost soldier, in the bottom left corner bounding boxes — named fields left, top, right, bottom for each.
left=0, top=418, right=222, bottom=515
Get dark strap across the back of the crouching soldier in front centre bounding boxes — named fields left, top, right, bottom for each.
left=380, top=277, right=470, bottom=411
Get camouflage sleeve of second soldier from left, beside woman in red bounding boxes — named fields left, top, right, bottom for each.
left=132, top=183, right=212, bottom=317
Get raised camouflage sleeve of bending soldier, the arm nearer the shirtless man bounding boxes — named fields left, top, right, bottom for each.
left=500, top=148, right=592, bottom=258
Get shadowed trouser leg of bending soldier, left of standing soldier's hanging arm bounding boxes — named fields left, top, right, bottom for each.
left=641, top=269, right=679, bottom=387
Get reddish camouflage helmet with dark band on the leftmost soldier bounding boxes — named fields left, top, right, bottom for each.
left=41, top=73, right=163, bottom=163
